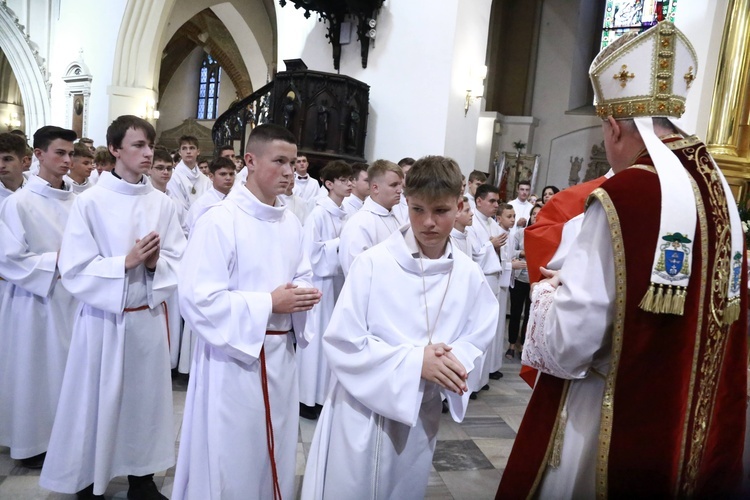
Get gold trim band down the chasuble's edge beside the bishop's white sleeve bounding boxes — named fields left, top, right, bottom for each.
left=587, top=188, right=626, bottom=498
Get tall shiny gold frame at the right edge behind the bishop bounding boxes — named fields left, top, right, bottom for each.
left=706, top=0, right=750, bottom=200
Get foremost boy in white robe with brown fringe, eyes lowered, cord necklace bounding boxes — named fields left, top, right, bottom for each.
left=302, top=156, right=497, bottom=500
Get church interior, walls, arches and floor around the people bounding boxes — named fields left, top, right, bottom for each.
left=0, top=0, right=750, bottom=499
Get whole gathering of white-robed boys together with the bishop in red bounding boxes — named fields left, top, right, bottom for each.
left=0, top=18, right=747, bottom=499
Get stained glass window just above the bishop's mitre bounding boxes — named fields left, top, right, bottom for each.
left=600, top=0, right=677, bottom=49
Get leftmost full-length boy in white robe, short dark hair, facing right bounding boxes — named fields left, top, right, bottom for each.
left=0, top=126, right=76, bottom=469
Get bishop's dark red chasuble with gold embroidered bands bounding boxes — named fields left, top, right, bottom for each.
left=497, top=137, right=748, bottom=498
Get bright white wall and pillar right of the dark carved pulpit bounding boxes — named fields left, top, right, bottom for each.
left=276, top=0, right=490, bottom=171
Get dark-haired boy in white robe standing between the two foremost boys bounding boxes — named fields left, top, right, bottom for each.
left=296, top=160, right=352, bottom=420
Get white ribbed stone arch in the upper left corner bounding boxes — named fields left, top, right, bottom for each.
left=0, top=2, right=51, bottom=134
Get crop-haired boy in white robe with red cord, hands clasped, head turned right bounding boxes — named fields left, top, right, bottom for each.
left=172, top=124, right=321, bottom=500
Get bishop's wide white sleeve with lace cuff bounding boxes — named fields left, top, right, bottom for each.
left=523, top=202, right=615, bottom=379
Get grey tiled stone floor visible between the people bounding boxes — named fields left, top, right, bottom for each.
left=0, top=360, right=531, bottom=500
